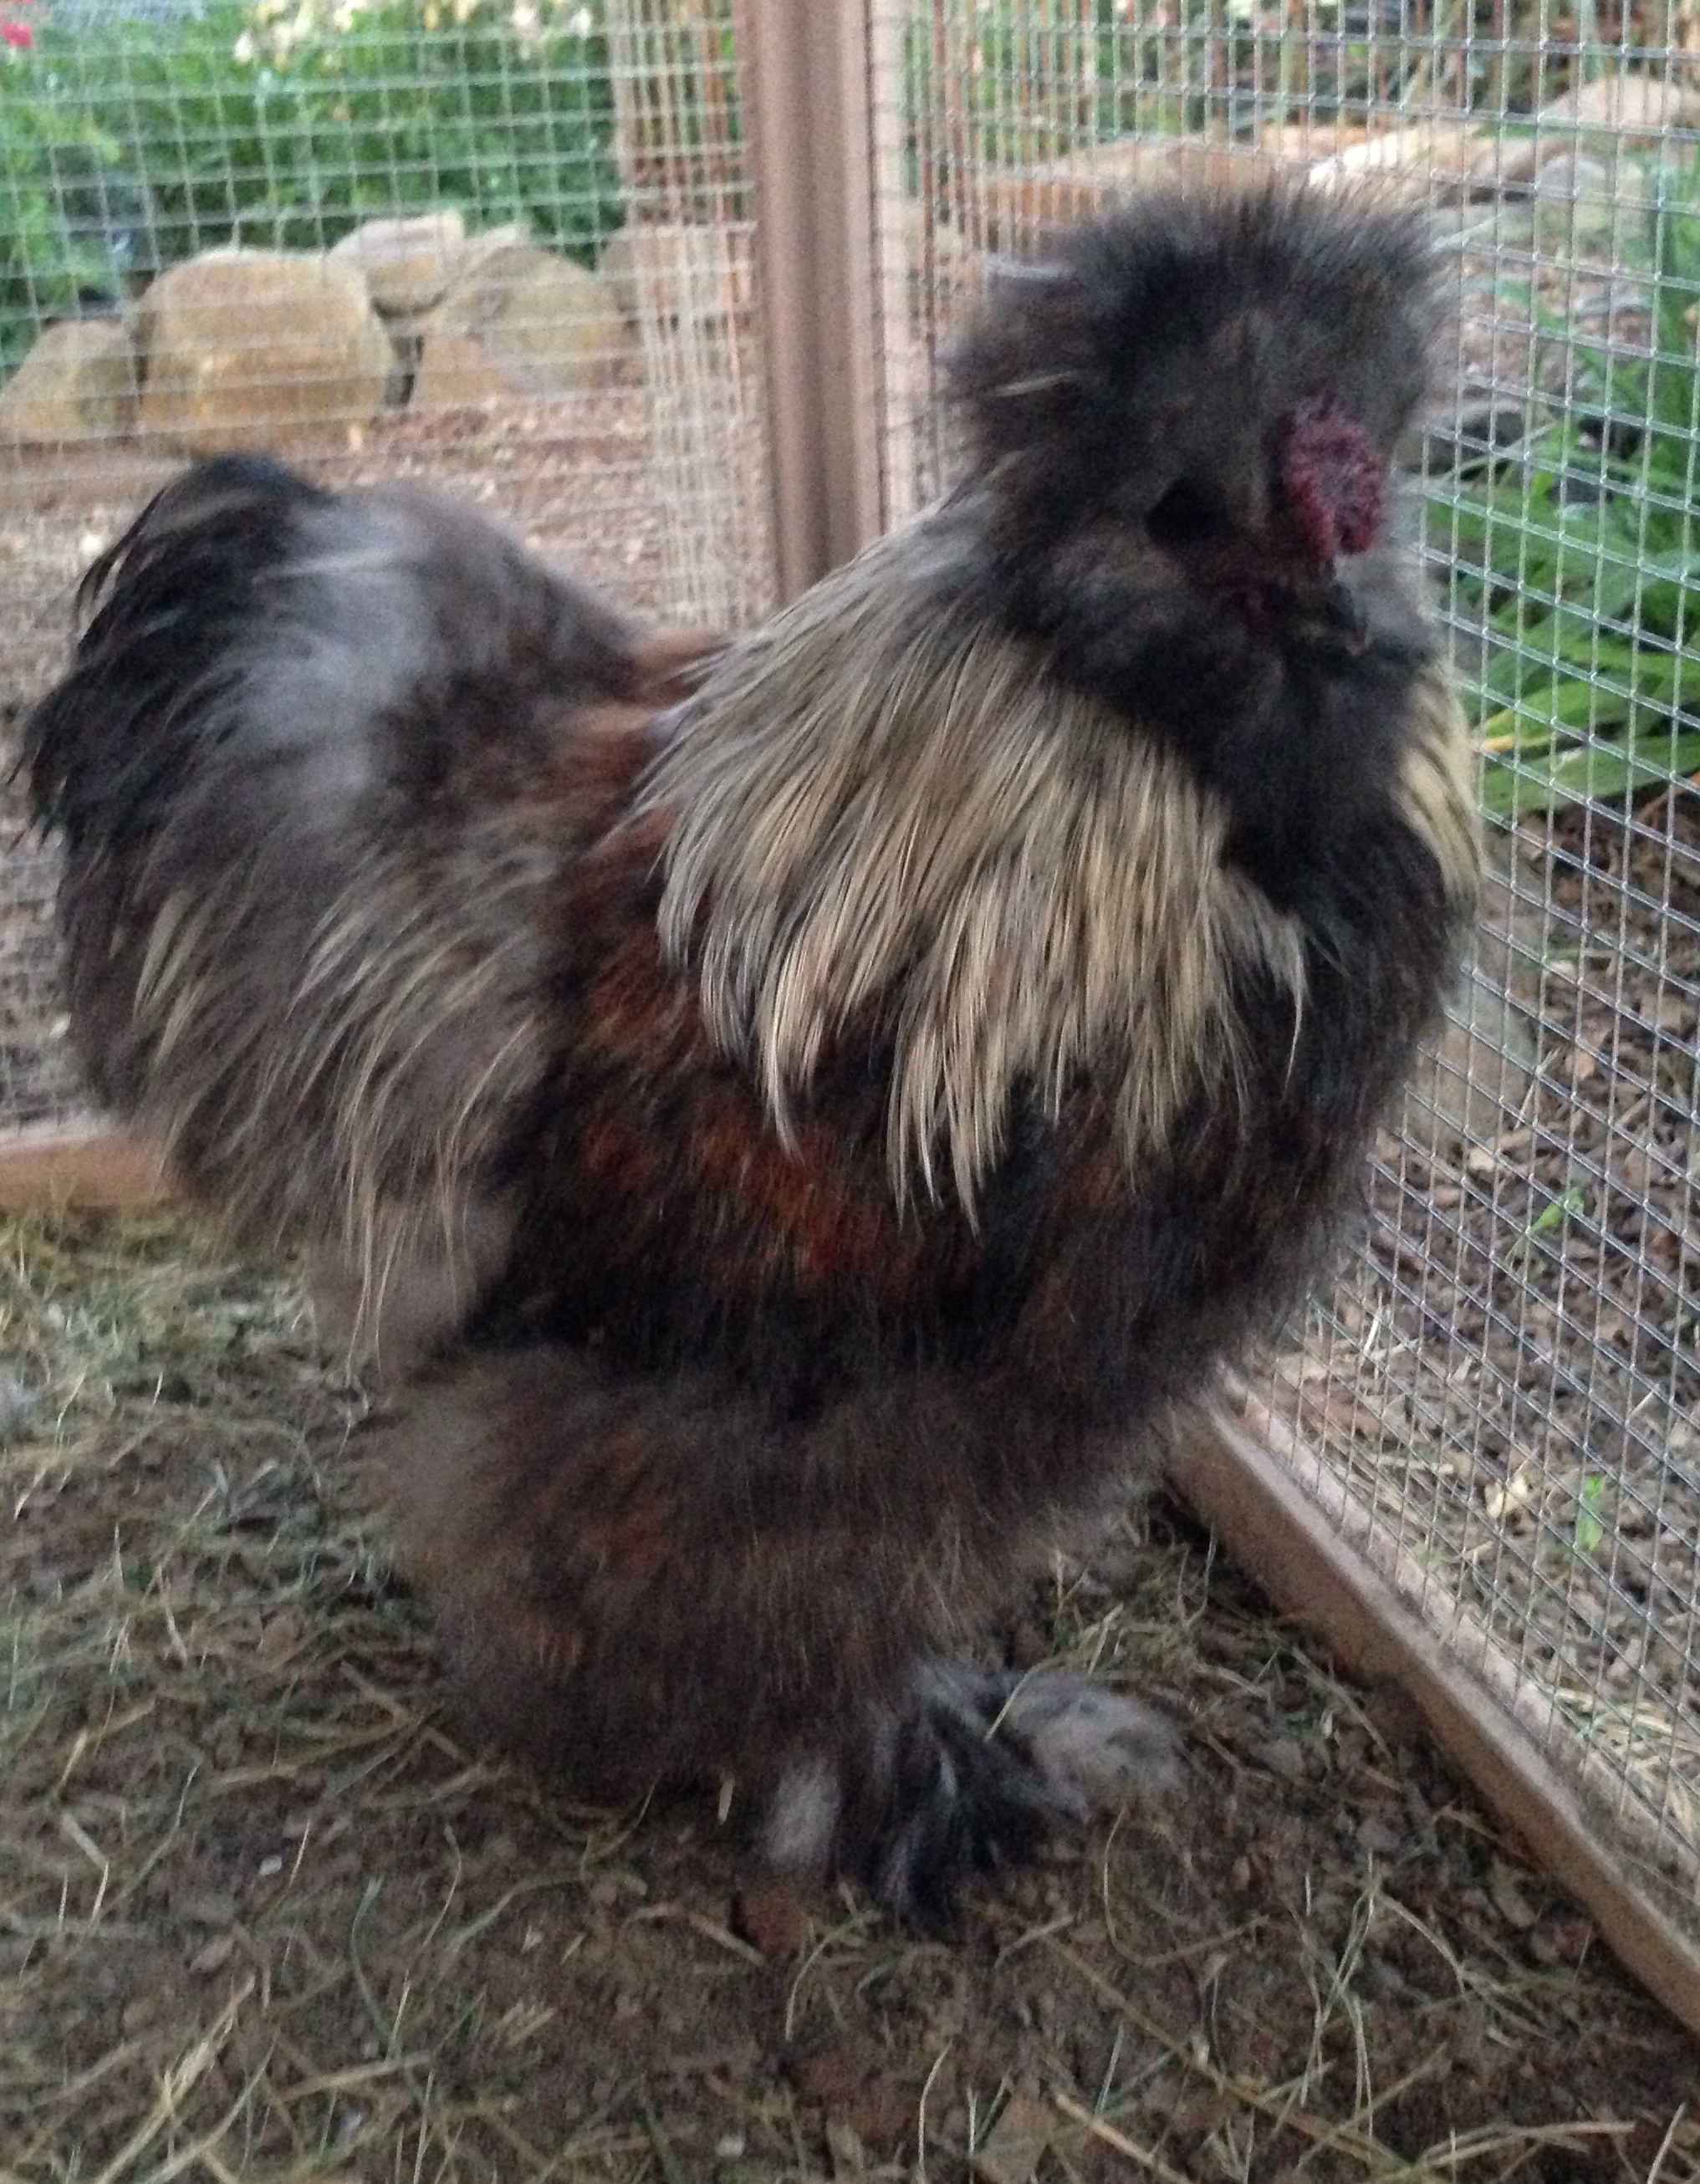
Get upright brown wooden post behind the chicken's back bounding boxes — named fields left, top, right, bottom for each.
left=738, top=0, right=881, bottom=599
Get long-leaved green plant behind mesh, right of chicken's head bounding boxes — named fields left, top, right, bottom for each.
left=1429, top=156, right=1700, bottom=819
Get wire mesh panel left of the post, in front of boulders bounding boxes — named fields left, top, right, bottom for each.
left=0, top=0, right=773, bottom=1129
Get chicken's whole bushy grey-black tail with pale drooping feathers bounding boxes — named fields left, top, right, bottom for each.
left=22, top=457, right=677, bottom=1354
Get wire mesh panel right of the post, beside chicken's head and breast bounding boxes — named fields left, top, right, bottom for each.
left=874, top=0, right=1700, bottom=1947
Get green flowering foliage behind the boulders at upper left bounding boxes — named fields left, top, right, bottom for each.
left=0, top=0, right=620, bottom=365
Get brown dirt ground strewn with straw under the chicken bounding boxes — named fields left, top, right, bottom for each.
left=0, top=1217, right=1700, bottom=2184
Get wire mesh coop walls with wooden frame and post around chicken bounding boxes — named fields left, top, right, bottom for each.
left=0, top=0, right=1700, bottom=2027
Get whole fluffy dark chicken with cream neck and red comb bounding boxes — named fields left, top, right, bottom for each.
left=26, top=190, right=1475, bottom=1917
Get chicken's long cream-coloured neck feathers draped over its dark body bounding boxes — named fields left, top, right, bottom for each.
left=641, top=515, right=1355, bottom=1214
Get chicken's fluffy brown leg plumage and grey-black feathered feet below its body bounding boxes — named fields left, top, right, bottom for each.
left=369, top=1350, right=1176, bottom=1926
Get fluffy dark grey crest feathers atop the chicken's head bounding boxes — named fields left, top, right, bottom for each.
left=948, top=181, right=1440, bottom=543
